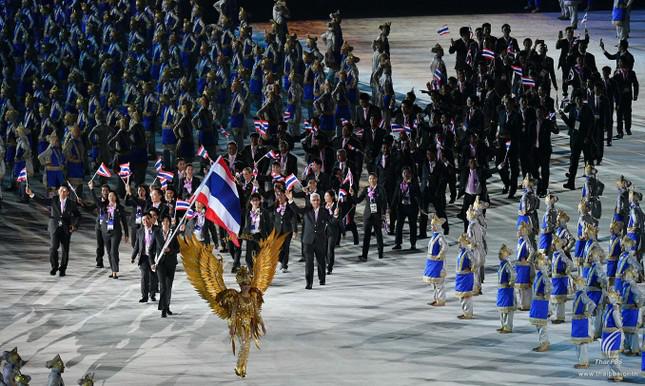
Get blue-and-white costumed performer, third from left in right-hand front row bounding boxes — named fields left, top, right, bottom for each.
left=496, top=244, right=515, bottom=334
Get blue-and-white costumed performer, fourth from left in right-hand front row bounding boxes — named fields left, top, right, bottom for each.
left=529, top=253, right=551, bottom=352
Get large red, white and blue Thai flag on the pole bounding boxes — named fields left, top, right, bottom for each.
left=197, top=157, right=242, bottom=247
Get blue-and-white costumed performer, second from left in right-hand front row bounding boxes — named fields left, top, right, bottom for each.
left=455, top=233, right=475, bottom=319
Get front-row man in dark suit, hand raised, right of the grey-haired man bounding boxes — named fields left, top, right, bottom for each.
left=349, top=173, right=387, bottom=261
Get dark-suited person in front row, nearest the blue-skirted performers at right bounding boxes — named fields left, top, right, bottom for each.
left=391, top=167, right=421, bottom=251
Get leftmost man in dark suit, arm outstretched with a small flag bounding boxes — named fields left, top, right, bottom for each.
left=25, top=186, right=81, bottom=277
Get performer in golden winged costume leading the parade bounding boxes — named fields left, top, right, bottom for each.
left=179, top=232, right=286, bottom=378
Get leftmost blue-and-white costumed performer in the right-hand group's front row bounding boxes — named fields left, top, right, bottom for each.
left=423, top=214, right=448, bottom=307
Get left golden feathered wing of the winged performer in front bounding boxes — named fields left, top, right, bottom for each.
left=177, top=236, right=231, bottom=320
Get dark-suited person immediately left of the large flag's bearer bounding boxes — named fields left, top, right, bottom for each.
left=130, top=213, right=157, bottom=303
